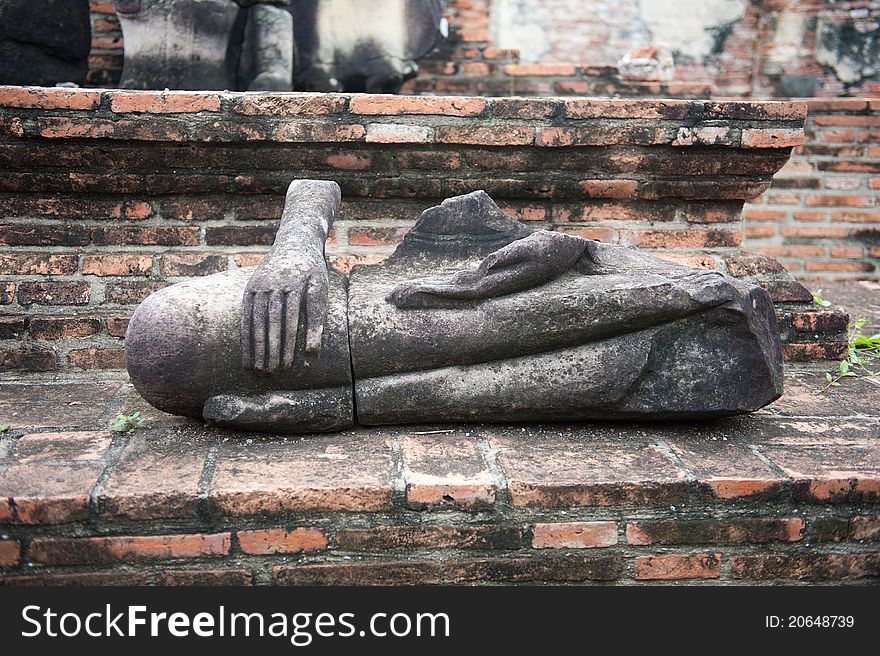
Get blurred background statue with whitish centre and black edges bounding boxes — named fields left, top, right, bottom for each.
left=290, top=0, right=443, bottom=93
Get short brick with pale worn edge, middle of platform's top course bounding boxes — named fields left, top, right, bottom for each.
left=400, top=431, right=495, bottom=510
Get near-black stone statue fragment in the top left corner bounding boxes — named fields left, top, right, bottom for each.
left=0, top=0, right=92, bottom=86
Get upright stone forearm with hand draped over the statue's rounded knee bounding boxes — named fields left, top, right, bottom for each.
left=241, top=180, right=341, bottom=373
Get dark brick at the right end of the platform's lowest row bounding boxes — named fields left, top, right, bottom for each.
left=730, top=553, right=880, bottom=581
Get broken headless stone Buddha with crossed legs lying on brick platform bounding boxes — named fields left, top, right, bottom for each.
left=125, top=180, right=782, bottom=432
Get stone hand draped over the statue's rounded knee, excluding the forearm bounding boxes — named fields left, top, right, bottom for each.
left=241, top=248, right=329, bottom=373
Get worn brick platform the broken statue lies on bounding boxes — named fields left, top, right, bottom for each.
left=0, top=280, right=880, bottom=585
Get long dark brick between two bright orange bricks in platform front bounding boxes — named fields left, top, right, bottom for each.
left=336, top=525, right=523, bottom=553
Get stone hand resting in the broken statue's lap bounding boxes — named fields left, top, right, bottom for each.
left=388, top=230, right=587, bottom=309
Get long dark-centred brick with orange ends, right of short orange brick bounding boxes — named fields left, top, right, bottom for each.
left=626, top=518, right=804, bottom=545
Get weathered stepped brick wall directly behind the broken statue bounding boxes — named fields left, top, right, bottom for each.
left=0, top=87, right=845, bottom=371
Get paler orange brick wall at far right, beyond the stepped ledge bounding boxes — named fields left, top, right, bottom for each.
left=743, top=99, right=880, bottom=283
